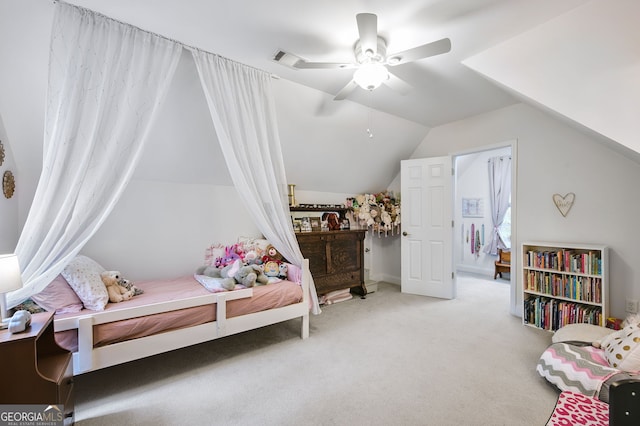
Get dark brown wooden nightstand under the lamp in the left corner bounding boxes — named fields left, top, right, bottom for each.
left=0, top=312, right=74, bottom=424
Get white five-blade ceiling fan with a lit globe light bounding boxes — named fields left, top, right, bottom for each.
left=273, top=13, right=451, bottom=100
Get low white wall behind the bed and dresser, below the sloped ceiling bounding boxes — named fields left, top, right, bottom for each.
left=82, top=179, right=360, bottom=280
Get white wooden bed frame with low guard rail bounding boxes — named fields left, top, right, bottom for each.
left=54, top=259, right=311, bottom=375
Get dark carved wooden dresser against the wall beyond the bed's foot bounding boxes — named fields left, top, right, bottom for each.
left=296, top=230, right=367, bottom=296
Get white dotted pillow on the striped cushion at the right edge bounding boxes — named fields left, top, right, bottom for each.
left=602, top=324, right=640, bottom=372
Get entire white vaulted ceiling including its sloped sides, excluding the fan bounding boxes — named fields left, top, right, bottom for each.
left=0, top=0, right=640, bottom=201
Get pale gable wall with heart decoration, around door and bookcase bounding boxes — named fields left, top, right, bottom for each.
left=381, top=104, right=640, bottom=318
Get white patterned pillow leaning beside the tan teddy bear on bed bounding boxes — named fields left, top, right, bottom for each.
left=62, top=255, right=109, bottom=311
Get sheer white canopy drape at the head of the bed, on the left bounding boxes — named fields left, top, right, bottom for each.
left=7, top=2, right=182, bottom=307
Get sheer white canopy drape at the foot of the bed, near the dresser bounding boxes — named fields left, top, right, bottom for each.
left=192, top=50, right=320, bottom=313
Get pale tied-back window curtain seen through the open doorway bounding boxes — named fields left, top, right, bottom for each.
left=484, top=156, right=511, bottom=255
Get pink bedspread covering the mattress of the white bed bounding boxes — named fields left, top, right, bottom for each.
left=55, top=276, right=302, bottom=352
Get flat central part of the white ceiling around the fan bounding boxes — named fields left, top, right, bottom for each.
left=69, top=0, right=587, bottom=127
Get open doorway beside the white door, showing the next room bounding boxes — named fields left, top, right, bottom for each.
left=453, top=141, right=516, bottom=313
